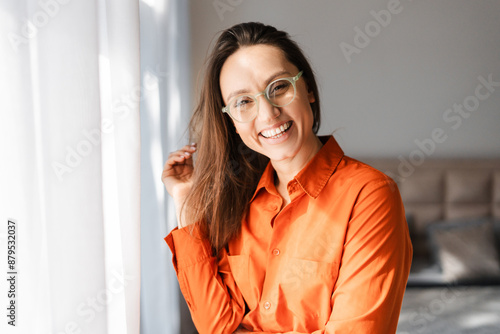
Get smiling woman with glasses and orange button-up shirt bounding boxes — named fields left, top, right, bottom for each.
left=162, top=23, right=412, bottom=334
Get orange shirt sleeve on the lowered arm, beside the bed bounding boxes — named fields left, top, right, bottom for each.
left=237, top=179, right=413, bottom=334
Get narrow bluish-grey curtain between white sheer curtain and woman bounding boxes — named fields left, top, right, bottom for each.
left=140, top=0, right=194, bottom=334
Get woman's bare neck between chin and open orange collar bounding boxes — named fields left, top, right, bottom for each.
left=271, top=135, right=323, bottom=194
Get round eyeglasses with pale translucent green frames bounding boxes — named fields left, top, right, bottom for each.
left=222, top=71, right=303, bottom=123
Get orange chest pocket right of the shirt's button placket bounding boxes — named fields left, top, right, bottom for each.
left=280, top=258, right=338, bottom=319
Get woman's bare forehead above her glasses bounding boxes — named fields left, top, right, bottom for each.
left=219, top=44, right=298, bottom=98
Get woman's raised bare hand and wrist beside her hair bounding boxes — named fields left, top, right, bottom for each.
left=161, top=144, right=196, bottom=228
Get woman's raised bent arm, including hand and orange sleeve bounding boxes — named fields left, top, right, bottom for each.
left=162, top=144, right=245, bottom=333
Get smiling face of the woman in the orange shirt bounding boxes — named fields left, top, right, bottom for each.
left=220, top=44, right=321, bottom=166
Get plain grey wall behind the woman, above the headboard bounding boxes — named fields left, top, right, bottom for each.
left=190, top=0, right=500, bottom=158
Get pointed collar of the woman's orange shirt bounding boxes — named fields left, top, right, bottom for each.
left=250, top=135, right=344, bottom=202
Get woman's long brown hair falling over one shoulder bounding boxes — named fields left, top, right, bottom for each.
left=182, top=22, right=320, bottom=255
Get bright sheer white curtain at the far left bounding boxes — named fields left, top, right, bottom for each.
left=0, top=0, right=141, bottom=334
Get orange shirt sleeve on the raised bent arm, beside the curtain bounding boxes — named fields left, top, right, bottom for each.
left=165, top=226, right=245, bottom=334
